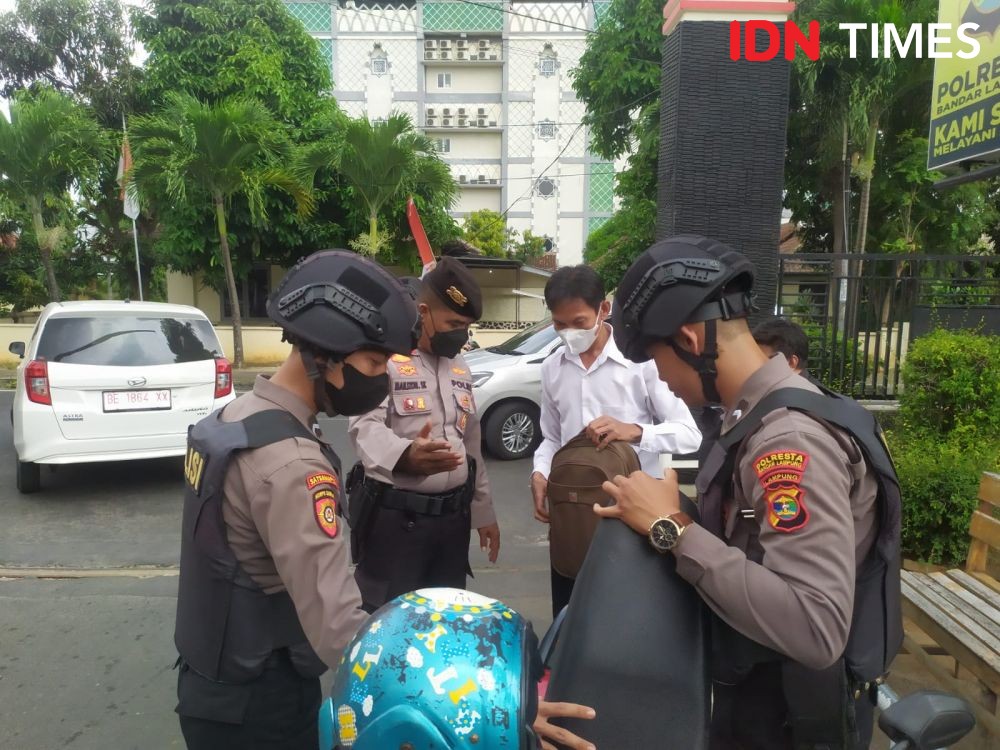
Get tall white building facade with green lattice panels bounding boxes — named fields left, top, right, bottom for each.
left=286, top=0, right=621, bottom=265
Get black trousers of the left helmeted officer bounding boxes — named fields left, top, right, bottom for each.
left=177, top=651, right=322, bottom=750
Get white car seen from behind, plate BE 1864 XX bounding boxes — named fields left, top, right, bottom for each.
left=10, top=301, right=236, bottom=493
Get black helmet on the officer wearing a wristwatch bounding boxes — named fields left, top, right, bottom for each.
left=611, top=234, right=756, bottom=401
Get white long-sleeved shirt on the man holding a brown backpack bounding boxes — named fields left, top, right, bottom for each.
left=534, top=325, right=701, bottom=478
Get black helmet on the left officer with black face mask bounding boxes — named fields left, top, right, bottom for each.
left=267, top=250, right=420, bottom=360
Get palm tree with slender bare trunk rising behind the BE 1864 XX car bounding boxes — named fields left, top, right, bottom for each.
left=129, top=94, right=313, bottom=367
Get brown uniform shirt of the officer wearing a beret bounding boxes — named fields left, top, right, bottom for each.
left=348, top=350, right=496, bottom=529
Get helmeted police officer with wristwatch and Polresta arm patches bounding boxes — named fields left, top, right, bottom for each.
left=595, top=236, right=902, bottom=750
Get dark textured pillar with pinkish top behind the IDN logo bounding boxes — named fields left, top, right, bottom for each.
left=656, top=0, right=794, bottom=318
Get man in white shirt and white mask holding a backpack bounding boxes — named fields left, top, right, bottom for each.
left=531, top=266, right=701, bottom=616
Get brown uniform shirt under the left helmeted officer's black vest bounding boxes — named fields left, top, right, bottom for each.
left=222, top=376, right=367, bottom=667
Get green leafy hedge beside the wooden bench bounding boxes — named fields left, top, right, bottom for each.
left=889, top=330, right=1000, bottom=565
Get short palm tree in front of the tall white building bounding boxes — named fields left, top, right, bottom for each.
left=336, top=113, right=455, bottom=255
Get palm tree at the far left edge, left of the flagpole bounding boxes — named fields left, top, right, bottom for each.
left=0, top=88, right=108, bottom=301
